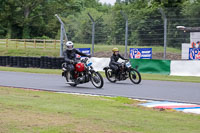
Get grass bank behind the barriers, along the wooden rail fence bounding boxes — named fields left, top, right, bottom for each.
left=0, top=41, right=181, bottom=57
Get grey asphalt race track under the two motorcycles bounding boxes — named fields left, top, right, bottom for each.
left=0, top=71, right=200, bottom=104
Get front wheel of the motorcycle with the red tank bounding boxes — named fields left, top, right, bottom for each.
left=90, top=72, right=104, bottom=88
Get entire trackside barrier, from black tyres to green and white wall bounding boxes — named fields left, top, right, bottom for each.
left=0, top=56, right=200, bottom=76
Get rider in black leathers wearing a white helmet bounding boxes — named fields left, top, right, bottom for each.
left=63, top=41, right=91, bottom=79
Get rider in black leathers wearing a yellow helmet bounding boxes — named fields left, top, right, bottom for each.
left=109, top=48, right=128, bottom=79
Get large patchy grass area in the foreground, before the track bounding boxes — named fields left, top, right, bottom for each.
left=0, top=87, right=200, bottom=133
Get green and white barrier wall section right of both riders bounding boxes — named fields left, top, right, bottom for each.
left=131, top=59, right=200, bottom=76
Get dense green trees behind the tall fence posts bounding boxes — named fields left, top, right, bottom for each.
left=0, top=0, right=200, bottom=47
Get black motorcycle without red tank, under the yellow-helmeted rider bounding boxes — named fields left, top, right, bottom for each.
left=103, top=60, right=142, bottom=84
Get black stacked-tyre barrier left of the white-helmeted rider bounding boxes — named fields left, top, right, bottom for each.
left=0, top=56, right=64, bottom=69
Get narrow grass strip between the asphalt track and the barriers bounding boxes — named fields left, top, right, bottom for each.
left=0, top=67, right=200, bottom=83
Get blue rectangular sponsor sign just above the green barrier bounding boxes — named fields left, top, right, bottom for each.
left=130, top=48, right=152, bottom=59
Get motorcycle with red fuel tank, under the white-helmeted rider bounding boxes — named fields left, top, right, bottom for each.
left=62, top=58, right=104, bottom=88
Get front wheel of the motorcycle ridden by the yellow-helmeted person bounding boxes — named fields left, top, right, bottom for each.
left=129, top=69, right=142, bottom=84
